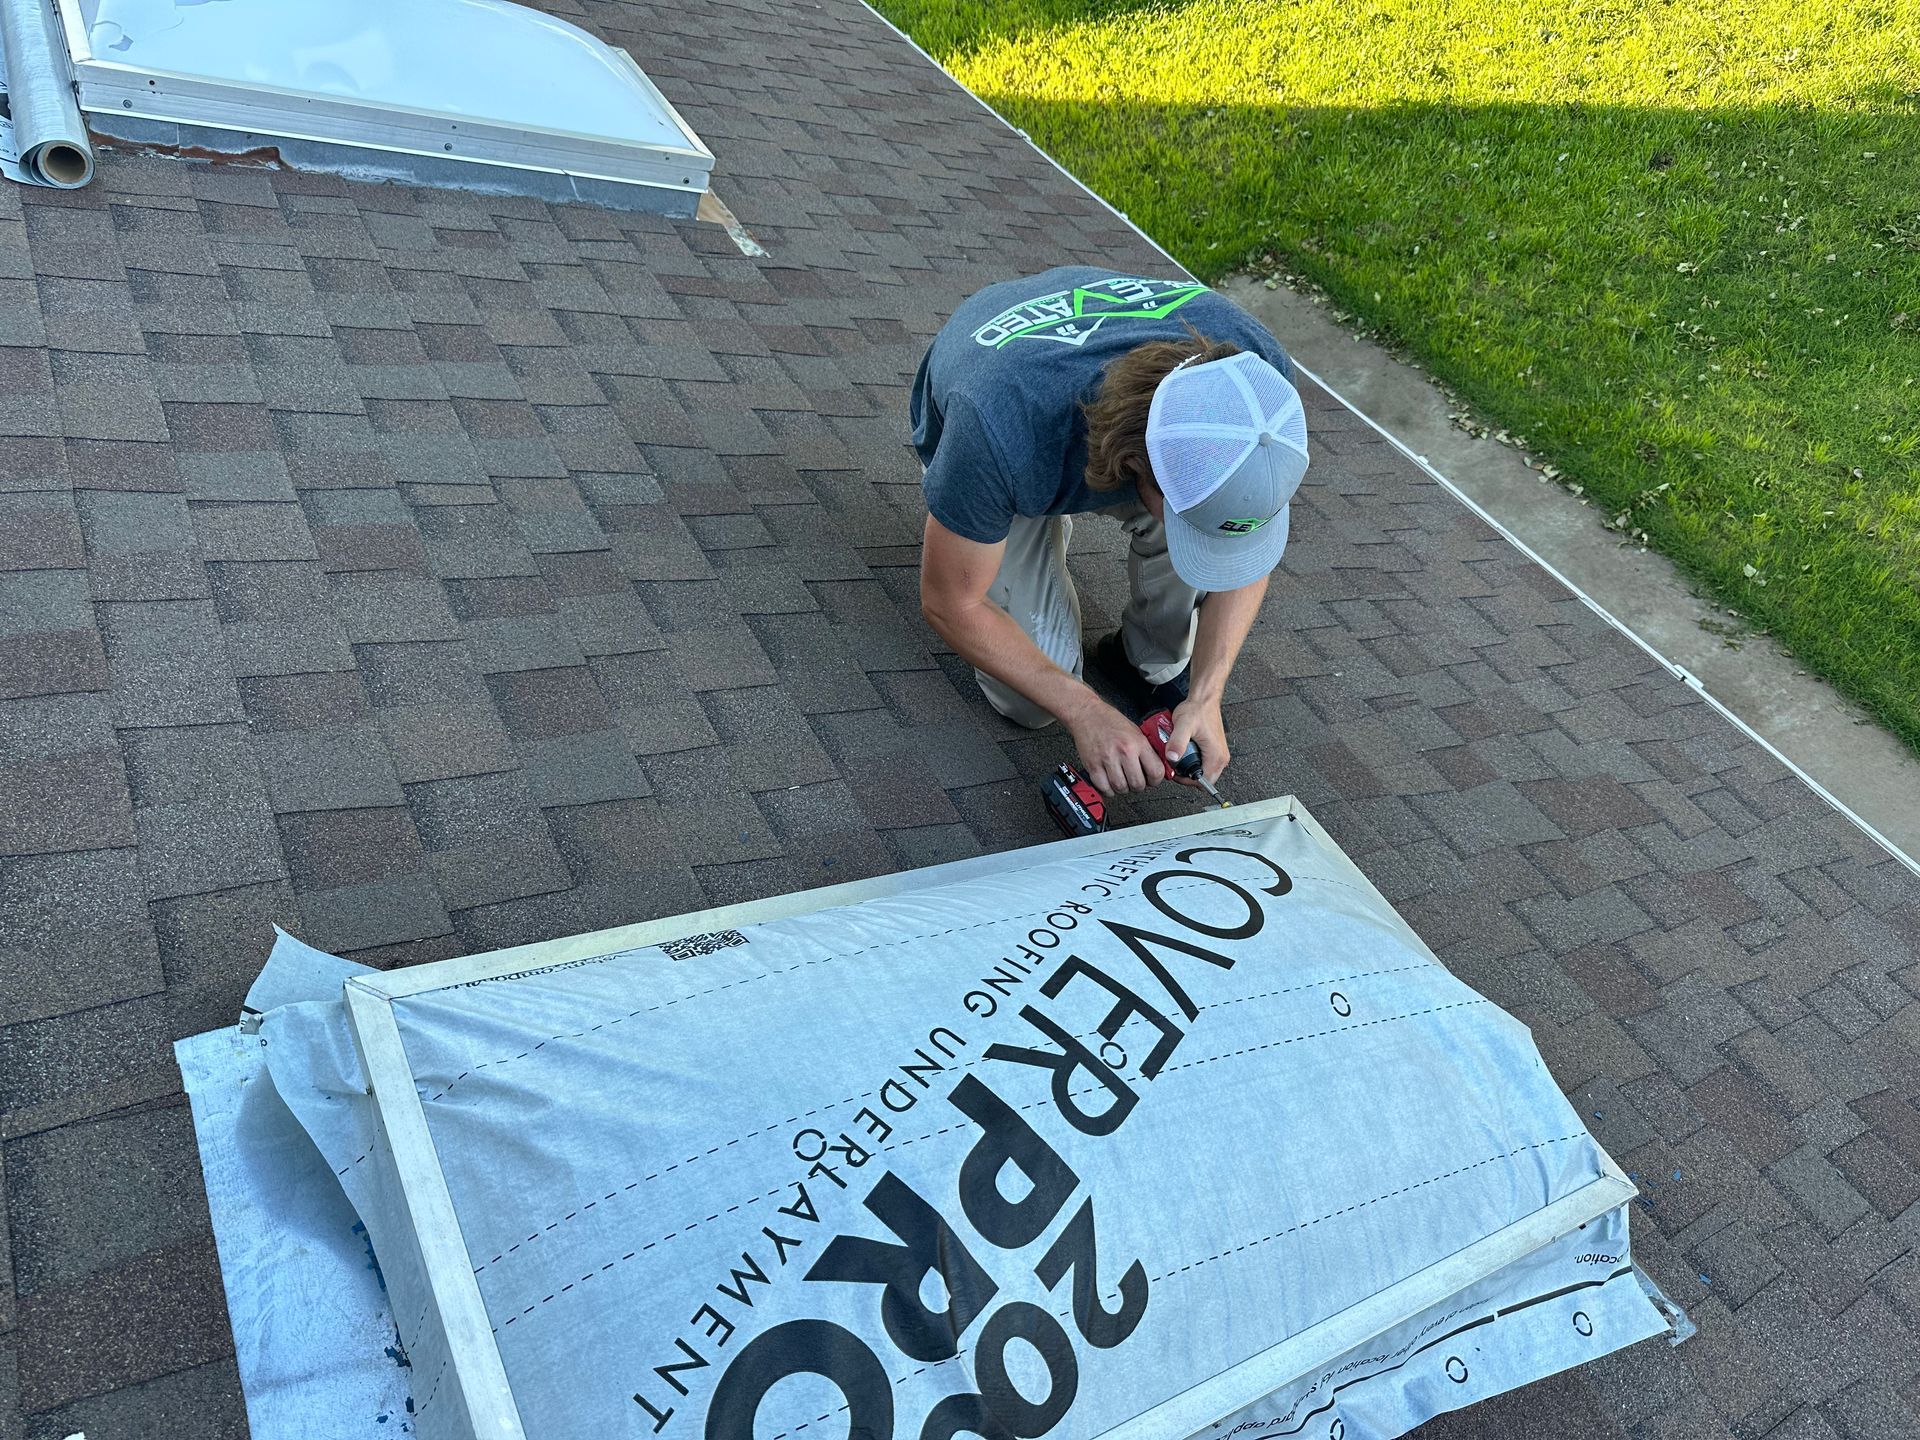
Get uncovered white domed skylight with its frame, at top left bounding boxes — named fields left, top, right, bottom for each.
left=58, top=0, right=712, bottom=213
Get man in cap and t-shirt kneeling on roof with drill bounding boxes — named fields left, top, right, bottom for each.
left=912, top=265, right=1308, bottom=795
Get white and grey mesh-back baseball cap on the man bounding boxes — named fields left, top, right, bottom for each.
left=1146, top=351, right=1308, bottom=593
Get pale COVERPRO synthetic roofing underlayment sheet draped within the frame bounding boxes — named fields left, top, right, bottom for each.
left=263, top=814, right=1667, bottom=1440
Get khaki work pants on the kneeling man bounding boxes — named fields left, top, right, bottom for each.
left=973, top=501, right=1200, bottom=730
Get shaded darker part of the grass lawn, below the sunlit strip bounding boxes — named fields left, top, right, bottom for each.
left=985, top=94, right=1920, bottom=745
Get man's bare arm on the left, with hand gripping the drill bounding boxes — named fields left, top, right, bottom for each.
left=920, top=515, right=1159, bottom=795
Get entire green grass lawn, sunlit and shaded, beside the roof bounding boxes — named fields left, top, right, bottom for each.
left=881, top=0, right=1920, bottom=747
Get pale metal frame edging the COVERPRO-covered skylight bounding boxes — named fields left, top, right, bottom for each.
left=334, top=795, right=1640, bottom=1440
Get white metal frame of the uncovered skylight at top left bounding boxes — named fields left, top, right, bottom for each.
left=56, top=0, right=714, bottom=196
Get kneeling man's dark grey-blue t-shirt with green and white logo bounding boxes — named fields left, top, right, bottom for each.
left=912, top=265, right=1292, bottom=545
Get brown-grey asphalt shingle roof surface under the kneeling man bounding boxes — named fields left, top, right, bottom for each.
left=0, top=0, right=1920, bottom=1440
